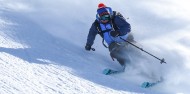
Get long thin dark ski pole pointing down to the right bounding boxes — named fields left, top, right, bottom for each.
left=120, top=37, right=166, bottom=64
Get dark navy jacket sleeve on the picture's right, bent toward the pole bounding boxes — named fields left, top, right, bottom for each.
left=114, top=16, right=131, bottom=36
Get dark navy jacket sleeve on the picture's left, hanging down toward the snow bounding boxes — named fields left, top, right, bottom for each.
left=86, top=23, right=98, bottom=46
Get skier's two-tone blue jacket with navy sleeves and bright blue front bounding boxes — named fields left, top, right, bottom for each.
left=86, top=11, right=131, bottom=46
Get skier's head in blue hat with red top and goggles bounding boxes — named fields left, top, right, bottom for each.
left=97, top=3, right=111, bottom=23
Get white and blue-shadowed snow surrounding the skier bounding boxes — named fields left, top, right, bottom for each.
left=0, top=0, right=190, bottom=94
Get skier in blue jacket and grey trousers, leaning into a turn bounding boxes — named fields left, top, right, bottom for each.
left=85, top=3, right=134, bottom=71
